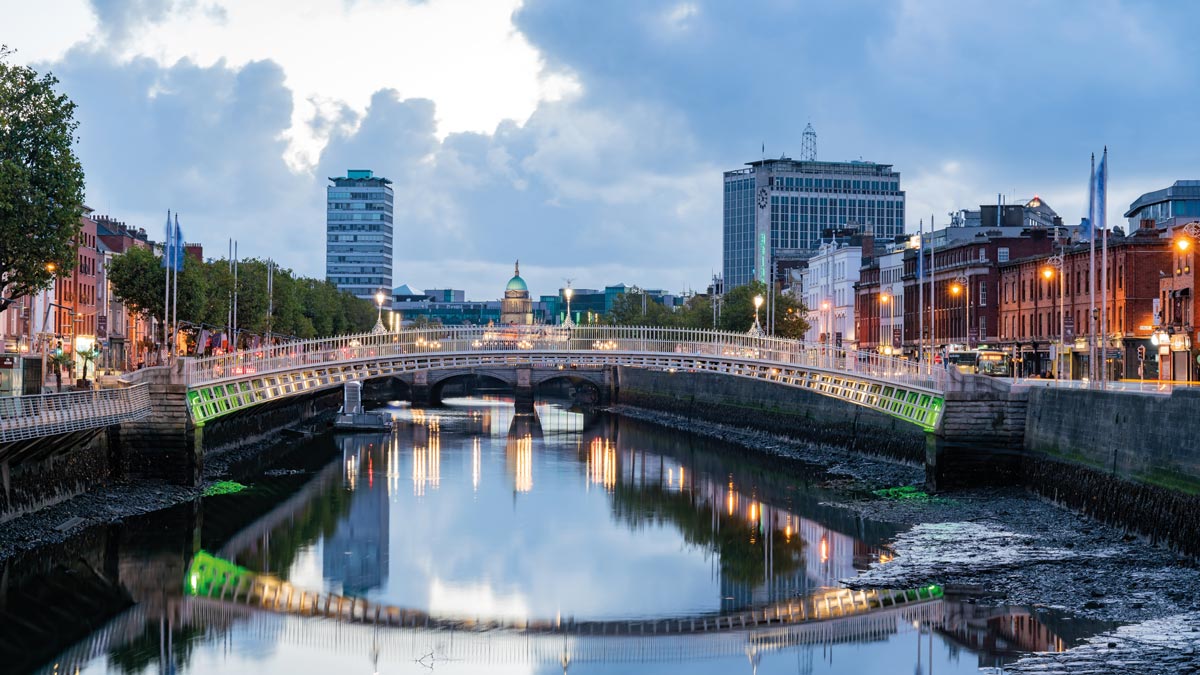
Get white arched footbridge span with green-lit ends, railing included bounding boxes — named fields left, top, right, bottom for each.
left=184, top=325, right=949, bottom=430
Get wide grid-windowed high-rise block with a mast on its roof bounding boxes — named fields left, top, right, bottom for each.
left=724, top=157, right=905, bottom=289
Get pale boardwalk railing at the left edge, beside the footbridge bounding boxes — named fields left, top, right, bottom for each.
left=0, top=384, right=150, bottom=443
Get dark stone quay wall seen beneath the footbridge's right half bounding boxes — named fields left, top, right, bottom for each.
left=617, top=368, right=926, bottom=464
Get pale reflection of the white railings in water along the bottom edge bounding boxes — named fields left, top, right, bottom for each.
left=38, top=597, right=944, bottom=675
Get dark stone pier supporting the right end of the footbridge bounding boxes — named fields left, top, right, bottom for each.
left=925, top=370, right=1030, bottom=490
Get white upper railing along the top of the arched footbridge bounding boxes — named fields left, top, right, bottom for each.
left=185, top=325, right=947, bottom=392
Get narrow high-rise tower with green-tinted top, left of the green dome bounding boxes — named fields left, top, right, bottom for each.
left=325, top=169, right=392, bottom=307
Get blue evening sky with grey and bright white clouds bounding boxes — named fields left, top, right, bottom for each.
left=7, top=0, right=1200, bottom=299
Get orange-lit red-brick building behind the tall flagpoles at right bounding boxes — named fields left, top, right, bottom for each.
left=997, top=222, right=1171, bottom=380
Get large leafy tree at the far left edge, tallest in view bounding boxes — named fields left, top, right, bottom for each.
left=0, top=46, right=84, bottom=311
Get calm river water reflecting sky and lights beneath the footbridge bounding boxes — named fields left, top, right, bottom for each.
left=0, top=399, right=1108, bottom=675
